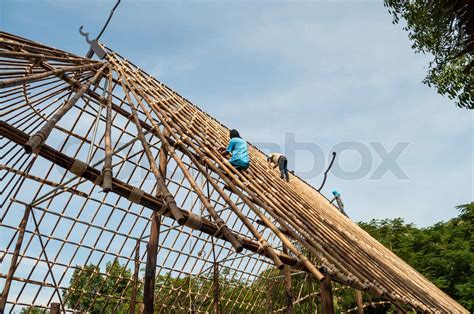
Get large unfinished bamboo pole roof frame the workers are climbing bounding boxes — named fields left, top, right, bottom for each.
left=0, top=32, right=467, bottom=313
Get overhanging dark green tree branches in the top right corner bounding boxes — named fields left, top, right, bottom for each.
left=385, top=0, right=474, bottom=109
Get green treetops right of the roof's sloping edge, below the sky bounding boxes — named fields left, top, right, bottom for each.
left=359, top=203, right=474, bottom=312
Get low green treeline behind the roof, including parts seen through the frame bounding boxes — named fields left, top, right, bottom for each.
left=57, top=203, right=474, bottom=313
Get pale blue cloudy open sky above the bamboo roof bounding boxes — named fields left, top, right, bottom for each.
left=0, top=0, right=474, bottom=227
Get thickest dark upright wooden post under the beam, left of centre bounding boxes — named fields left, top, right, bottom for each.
left=143, top=212, right=161, bottom=314
